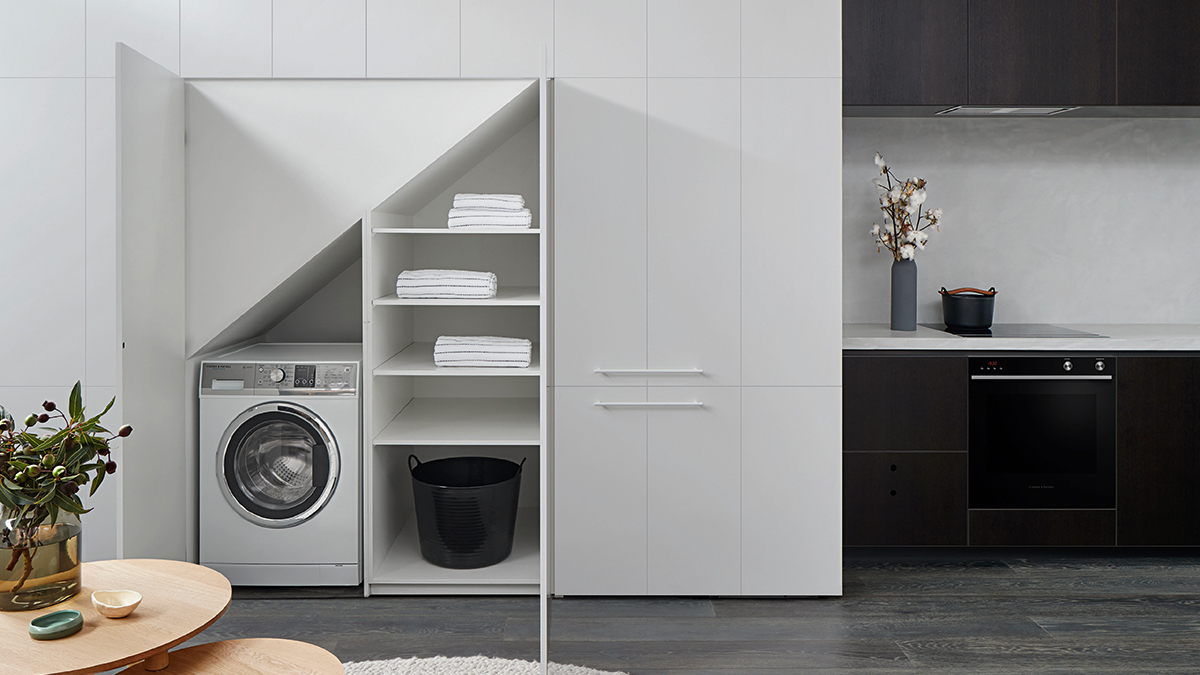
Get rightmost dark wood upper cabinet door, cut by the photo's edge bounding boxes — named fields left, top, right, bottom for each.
left=1117, top=0, right=1200, bottom=106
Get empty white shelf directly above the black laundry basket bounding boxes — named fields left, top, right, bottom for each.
left=373, top=398, right=541, bottom=446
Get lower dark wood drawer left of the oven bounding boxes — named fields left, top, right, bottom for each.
left=842, top=453, right=967, bottom=546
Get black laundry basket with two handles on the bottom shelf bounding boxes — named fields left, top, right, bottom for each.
left=408, top=455, right=528, bottom=569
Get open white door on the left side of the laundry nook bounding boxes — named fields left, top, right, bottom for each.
left=116, top=46, right=190, bottom=560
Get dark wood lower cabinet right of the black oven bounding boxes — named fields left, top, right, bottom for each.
left=1117, top=356, right=1200, bottom=546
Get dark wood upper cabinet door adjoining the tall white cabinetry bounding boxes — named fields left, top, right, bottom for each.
left=841, top=0, right=967, bottom=106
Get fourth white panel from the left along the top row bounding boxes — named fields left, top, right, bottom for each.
left=271, top=0, right=367, bottom=77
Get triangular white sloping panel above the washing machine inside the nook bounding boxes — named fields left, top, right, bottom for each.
left=186, top=80, right=528, bottom=354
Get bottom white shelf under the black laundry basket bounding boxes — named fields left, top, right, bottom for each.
left=371, top=507, right=541, bottom=595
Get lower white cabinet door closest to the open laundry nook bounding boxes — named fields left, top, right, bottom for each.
left=553, top=387, right=647, bottom=596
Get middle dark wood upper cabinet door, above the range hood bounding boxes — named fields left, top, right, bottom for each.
left=968, top=0, right=1113, bottom=106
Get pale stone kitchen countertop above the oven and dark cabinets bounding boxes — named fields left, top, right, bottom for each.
left=841, top=323, right=1200, bottom=352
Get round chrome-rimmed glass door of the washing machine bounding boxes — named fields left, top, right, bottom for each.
left=217, top=401, right=338, bottom=527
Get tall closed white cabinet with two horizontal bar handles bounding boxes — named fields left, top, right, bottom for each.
left=552, top=77, right=841, bottom=596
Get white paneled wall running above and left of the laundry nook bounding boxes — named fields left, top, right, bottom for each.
left=0, top=0, right=840, bottom=557
